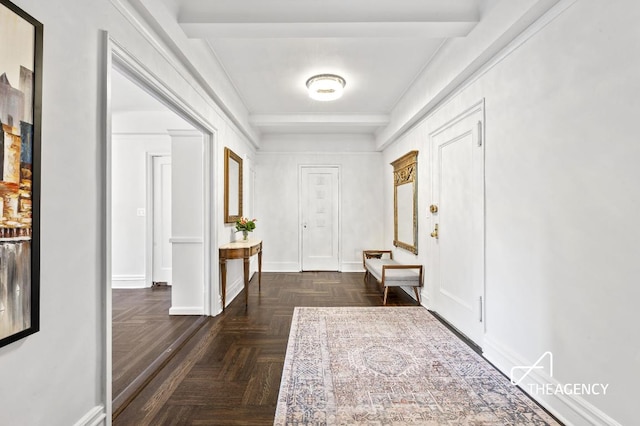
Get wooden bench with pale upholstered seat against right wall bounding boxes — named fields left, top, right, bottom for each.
left=362, top=250, right=422, bottom=305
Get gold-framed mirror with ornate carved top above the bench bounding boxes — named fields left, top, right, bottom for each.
left=391, top=151, right=418, bottom=254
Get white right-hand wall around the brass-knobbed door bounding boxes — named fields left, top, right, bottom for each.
left=385, top=0, right=640, bottom=424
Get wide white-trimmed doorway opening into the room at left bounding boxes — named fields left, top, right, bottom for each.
left=104, top=36, right=217, bottom=424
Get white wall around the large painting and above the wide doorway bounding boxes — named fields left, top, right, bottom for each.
left=0, top=0, right=255, bottom=426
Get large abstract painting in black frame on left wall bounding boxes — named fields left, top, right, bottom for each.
left=0, top=0, right=43, bottom=347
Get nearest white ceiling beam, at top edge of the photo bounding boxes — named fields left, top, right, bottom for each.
left=178, top=0, right=481, bottom=38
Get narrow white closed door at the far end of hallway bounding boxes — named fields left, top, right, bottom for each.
left=300, top=166, right=340, bottom=271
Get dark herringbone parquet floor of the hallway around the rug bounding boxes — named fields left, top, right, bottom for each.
left=114, top=272, right=417, bottom=426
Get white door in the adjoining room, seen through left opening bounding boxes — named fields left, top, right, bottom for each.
left=151, top=156, right=172, bottom=284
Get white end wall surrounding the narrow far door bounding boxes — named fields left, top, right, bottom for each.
left=256, top=135, right=384, bottom=272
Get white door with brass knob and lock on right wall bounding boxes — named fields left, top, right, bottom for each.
left=431, top=105, right=484, bottom=345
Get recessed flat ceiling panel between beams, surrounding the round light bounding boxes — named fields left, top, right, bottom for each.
left=209, top=38, right=443, bottom=114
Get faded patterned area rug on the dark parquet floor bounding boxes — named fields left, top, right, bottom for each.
left=274, top=307, right=557, bottom=426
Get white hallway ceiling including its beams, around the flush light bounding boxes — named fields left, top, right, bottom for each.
left=117, top=0, right=488, bottom=135
